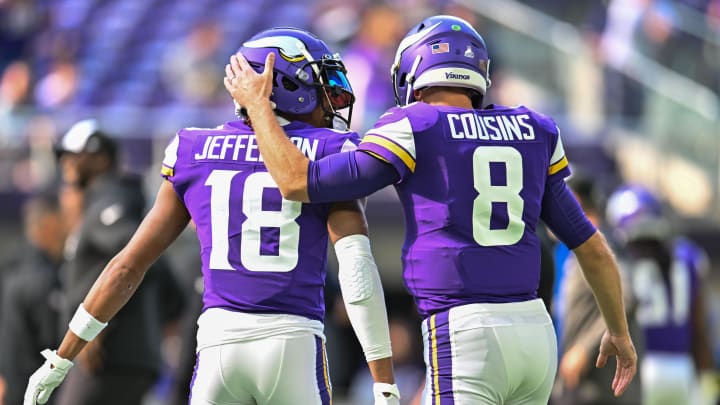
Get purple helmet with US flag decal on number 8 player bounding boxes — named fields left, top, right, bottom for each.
left=390, top=15, right=490, bottom=108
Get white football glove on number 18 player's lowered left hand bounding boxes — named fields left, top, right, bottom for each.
left=23, top=349, right=73, bottom=405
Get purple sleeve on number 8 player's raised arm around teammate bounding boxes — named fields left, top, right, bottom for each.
left=307, top=150, right=400, bottom=203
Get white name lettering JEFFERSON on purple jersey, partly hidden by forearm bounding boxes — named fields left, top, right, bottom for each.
left=195, top=134, right=319, bottom=162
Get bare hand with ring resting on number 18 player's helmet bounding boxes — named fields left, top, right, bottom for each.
left=224, top=52, right=275, bottom=112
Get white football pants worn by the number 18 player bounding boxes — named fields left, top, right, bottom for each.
left=190, top=308, right=332, bottom=405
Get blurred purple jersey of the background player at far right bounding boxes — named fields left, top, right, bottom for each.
left=632, top=239, right=707, bottom=353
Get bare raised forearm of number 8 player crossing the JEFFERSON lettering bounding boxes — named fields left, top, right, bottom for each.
left=246, top=99, right=309, bottom=202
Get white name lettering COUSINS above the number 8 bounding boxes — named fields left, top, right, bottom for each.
left=447, top=112, right=535, bottom=141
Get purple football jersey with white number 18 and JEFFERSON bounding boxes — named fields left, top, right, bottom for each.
left=162, top=121, right=359, bottom=321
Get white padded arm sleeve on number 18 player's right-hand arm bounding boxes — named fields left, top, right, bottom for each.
left=335, top=235, right=392, bottom=361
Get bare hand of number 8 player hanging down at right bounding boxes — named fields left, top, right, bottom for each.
left=596, top=331, right=637, bottom=397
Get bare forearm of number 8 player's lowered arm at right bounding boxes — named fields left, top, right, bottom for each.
left=574, top=232, right=628, bottom=336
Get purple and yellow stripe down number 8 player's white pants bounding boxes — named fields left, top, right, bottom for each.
left=425, top=311, right=455, bottom=405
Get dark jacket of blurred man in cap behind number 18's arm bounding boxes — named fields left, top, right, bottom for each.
left=62, top=173, right=182, bottom=371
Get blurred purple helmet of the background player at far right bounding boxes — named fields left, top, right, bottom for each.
left=605, top=185, right=670, bottom=242
